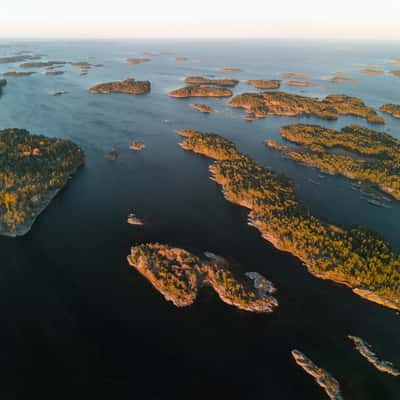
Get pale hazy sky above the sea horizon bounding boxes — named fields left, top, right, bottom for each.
left=0, top=0, right=400, bottom=40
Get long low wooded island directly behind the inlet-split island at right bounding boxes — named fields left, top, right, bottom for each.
left=229, top=92, right=385, bottom=124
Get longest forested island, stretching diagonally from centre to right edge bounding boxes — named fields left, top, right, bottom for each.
left=179, top=130, right=400, bottom=309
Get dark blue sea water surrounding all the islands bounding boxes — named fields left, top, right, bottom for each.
left=0, top=41, right=400, bottom=400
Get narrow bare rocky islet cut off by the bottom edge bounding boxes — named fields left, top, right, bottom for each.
left=292, top=350, right=343, bottom=400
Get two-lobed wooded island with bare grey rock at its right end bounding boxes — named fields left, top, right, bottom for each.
left=128, top=243, right=278, bottom=312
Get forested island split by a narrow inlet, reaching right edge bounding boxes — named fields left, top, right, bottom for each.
left=266, top=124, right=400, bottom=200
